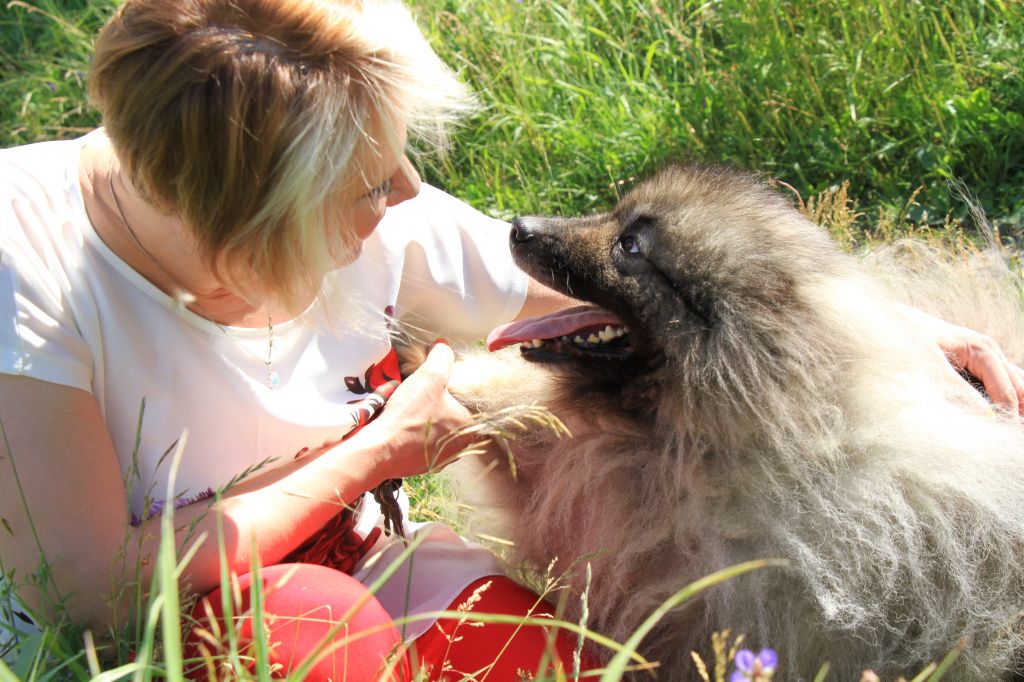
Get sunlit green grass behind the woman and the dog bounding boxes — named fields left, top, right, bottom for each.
left=0, top=0, right=1024, bottom=680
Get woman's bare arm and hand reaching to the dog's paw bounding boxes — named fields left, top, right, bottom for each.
left=0, top=346, right=468, bottom=631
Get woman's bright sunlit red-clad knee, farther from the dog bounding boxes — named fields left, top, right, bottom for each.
left=186, top=563, right=409, bottom=682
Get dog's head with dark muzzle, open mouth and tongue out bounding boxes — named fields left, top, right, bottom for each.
left=488, top=166, right=840, bottom=417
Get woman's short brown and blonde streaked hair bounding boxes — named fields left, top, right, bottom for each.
left=89, top=0, right=472, bottom=303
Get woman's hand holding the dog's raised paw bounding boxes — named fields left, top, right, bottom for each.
left=351, top=343, right=471, bottom=480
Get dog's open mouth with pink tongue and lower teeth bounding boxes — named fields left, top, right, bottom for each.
left=487, top=305, right=633, bottom=360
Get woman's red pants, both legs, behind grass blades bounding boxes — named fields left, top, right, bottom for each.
left=186, top=564, right=594, bottom=682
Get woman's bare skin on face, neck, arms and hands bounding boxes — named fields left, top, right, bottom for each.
left=0, top=130, right=1024, bottom=632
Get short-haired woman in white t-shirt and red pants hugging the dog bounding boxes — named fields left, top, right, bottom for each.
left=0, top=0, right=1024, bottom=680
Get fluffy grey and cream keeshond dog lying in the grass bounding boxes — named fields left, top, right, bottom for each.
left=451, top=167, right=1024, bottom=681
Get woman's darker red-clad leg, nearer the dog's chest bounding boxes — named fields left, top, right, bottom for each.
left=410, top=576, right=597, bottom=682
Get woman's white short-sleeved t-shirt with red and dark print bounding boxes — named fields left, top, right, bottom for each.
left=0, top=130, right=527, bottom=638
